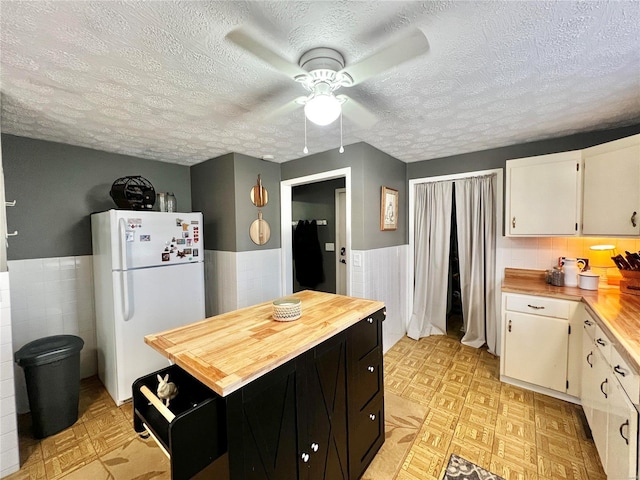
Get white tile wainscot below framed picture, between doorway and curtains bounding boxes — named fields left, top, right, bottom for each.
left=351, top=245, right=409, bottom=352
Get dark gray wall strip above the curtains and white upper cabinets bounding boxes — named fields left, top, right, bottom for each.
left=407, top=124, right=640, bottom=180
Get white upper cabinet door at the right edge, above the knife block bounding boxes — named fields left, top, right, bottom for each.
left=582, top=135, right=640, bottom=237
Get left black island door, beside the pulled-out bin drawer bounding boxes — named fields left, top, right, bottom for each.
left=227, top=359, right=299, bottom=480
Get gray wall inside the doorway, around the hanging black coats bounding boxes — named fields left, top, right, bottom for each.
left=291, top=178, right=345, bottom=293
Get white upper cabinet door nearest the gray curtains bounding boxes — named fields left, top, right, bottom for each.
left=505, top=151, right=582, bottom=237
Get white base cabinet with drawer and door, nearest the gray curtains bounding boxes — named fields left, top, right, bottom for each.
left=500, top=294, right=582, bottom=399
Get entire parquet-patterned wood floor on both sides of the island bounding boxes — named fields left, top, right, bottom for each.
left=6, top=333, right=606, bottom=480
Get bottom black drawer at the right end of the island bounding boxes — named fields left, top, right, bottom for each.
left=349, top=394, right=384, bottom=478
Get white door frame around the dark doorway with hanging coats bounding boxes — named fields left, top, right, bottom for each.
left=280, top=167, right=352, bottom=295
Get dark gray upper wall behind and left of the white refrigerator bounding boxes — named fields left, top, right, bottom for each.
left=1, top=134, right=191, bottom=260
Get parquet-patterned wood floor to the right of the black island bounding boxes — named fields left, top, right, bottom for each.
left=384, top=334, right=606, bottom=480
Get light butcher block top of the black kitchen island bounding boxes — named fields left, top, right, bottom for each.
left=144, top=290, right=384, bottom=397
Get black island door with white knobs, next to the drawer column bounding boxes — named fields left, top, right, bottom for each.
left=297, top=334, right=349, bottom=480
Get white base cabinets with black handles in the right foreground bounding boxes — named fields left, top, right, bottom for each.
left=581, top=313, right=640, bottom=479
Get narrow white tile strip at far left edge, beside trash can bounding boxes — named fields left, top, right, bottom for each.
left=0, top=272, right=20, bottom=477
